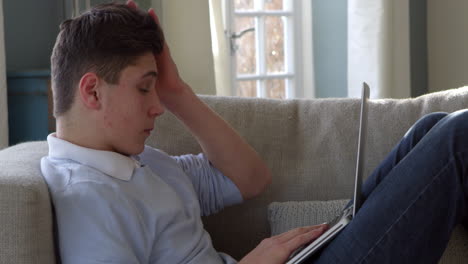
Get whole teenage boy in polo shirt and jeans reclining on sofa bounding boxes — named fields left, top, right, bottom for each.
left=41, top=2, right=468, bottom=264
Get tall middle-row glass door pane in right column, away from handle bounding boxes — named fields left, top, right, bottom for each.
left=265, top=16, right=285, bottom=72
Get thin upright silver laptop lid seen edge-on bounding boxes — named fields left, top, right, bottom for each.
left=353, top=83, right=370, bottom=218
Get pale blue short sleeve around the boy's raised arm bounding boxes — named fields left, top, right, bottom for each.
left=173, top=153, right=243, bottom=215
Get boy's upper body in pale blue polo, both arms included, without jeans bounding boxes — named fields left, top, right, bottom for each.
left=41, top=1, right=326, bottom=264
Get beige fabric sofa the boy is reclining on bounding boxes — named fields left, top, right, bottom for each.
left=0, top=87, right=468, bottom=264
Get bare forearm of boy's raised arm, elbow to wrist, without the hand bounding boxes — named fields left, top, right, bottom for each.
left=166, top=87, right=271, bottom=199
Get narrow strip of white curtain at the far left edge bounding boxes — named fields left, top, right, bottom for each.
left=0, top=0, right=8, bottom=149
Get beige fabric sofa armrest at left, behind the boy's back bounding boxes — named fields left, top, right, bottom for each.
left=0, top=142, right=55, bottom=264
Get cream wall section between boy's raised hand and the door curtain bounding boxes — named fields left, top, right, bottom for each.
left=158, top=0, right=216, bottom=94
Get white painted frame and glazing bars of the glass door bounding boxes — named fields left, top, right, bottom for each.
left=224, top=0, right=306, bottom=99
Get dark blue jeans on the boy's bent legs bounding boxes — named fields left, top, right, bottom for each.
left=308, top=110, right=468, bottom=264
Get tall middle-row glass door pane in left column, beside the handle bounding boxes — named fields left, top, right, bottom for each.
left=234, top=17, right=257, bottom=74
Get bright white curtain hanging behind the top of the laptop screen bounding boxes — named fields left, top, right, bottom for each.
left=348, top=0, right=411, bottom=98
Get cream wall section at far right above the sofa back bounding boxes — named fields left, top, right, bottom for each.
left=427, top=0, right=468, bottom=92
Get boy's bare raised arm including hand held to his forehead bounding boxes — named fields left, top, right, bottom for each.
left=144, top=5, right=271, bottom=199
